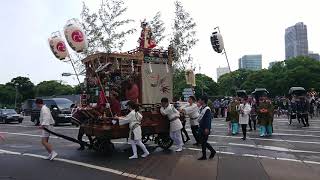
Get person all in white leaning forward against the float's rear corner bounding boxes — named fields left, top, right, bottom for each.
left=160, top=98, right=183, bottom=152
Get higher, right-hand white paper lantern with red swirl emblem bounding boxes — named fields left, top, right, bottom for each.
left=64, top=19, right=88, bottom=52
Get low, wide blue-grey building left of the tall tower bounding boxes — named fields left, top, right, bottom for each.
left=239, top=54, right=262, bottom=70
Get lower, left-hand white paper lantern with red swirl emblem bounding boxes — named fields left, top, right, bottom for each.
left=48, top=32, right=69, bottom=60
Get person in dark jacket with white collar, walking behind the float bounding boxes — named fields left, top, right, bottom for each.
left=198, top=96, right=216, bottom=160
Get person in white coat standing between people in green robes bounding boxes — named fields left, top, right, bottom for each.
left=239, top=98, right=251, bottom=140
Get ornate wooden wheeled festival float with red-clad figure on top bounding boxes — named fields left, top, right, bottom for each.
left=48, top=21, right=173, bottom=153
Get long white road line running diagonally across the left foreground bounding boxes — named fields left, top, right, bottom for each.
left=0, top=149, right=156, bottom=180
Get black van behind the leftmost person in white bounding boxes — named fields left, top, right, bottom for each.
left=31, top=98, right=73, bottom=126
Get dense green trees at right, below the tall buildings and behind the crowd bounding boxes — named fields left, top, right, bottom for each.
left=218, top=57, right=320, bottom=96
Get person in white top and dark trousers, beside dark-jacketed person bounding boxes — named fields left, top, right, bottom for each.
left=182, top=96, right=200, bottom=146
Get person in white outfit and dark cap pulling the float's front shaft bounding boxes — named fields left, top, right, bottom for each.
left=35, top=99, right=58, bottom=160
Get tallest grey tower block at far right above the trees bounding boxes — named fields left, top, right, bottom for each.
left=285, top=22, right=308, bottom=59
